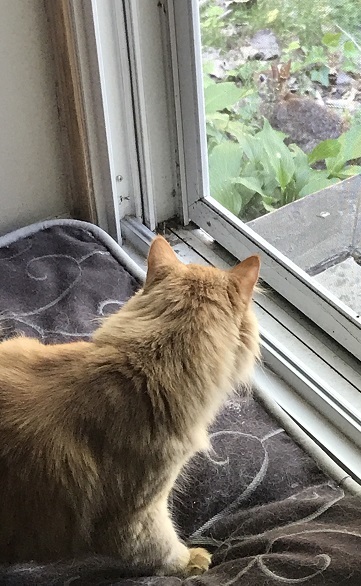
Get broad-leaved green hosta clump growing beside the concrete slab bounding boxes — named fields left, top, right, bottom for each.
left=209, top=120, right=340, bottom=220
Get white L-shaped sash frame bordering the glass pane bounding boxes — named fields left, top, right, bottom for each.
left=169, top=0, right=361, bottom=360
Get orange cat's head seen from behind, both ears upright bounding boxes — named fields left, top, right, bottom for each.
left=144, top=236, right=260, bottom=382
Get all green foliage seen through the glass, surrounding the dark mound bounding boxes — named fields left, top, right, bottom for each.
left=201, top=0, right=361, bottom=221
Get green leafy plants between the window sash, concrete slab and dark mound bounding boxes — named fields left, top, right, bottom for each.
left=205, top=73, right=361, bottom=221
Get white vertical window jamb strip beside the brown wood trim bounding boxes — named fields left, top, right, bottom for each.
left=68, top=0, right=142, bottom=243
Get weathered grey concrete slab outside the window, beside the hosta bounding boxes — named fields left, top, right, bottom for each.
left=248, top=176, right=361, bottom=314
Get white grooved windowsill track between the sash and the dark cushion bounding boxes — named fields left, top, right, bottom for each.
left=122, top=214, right=361, bottom=493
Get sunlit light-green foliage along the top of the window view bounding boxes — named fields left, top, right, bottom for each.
left=200, top=0, right=361, bottom=93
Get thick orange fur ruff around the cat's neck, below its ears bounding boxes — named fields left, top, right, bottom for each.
left=94, top=280, right=259, bottom=424
